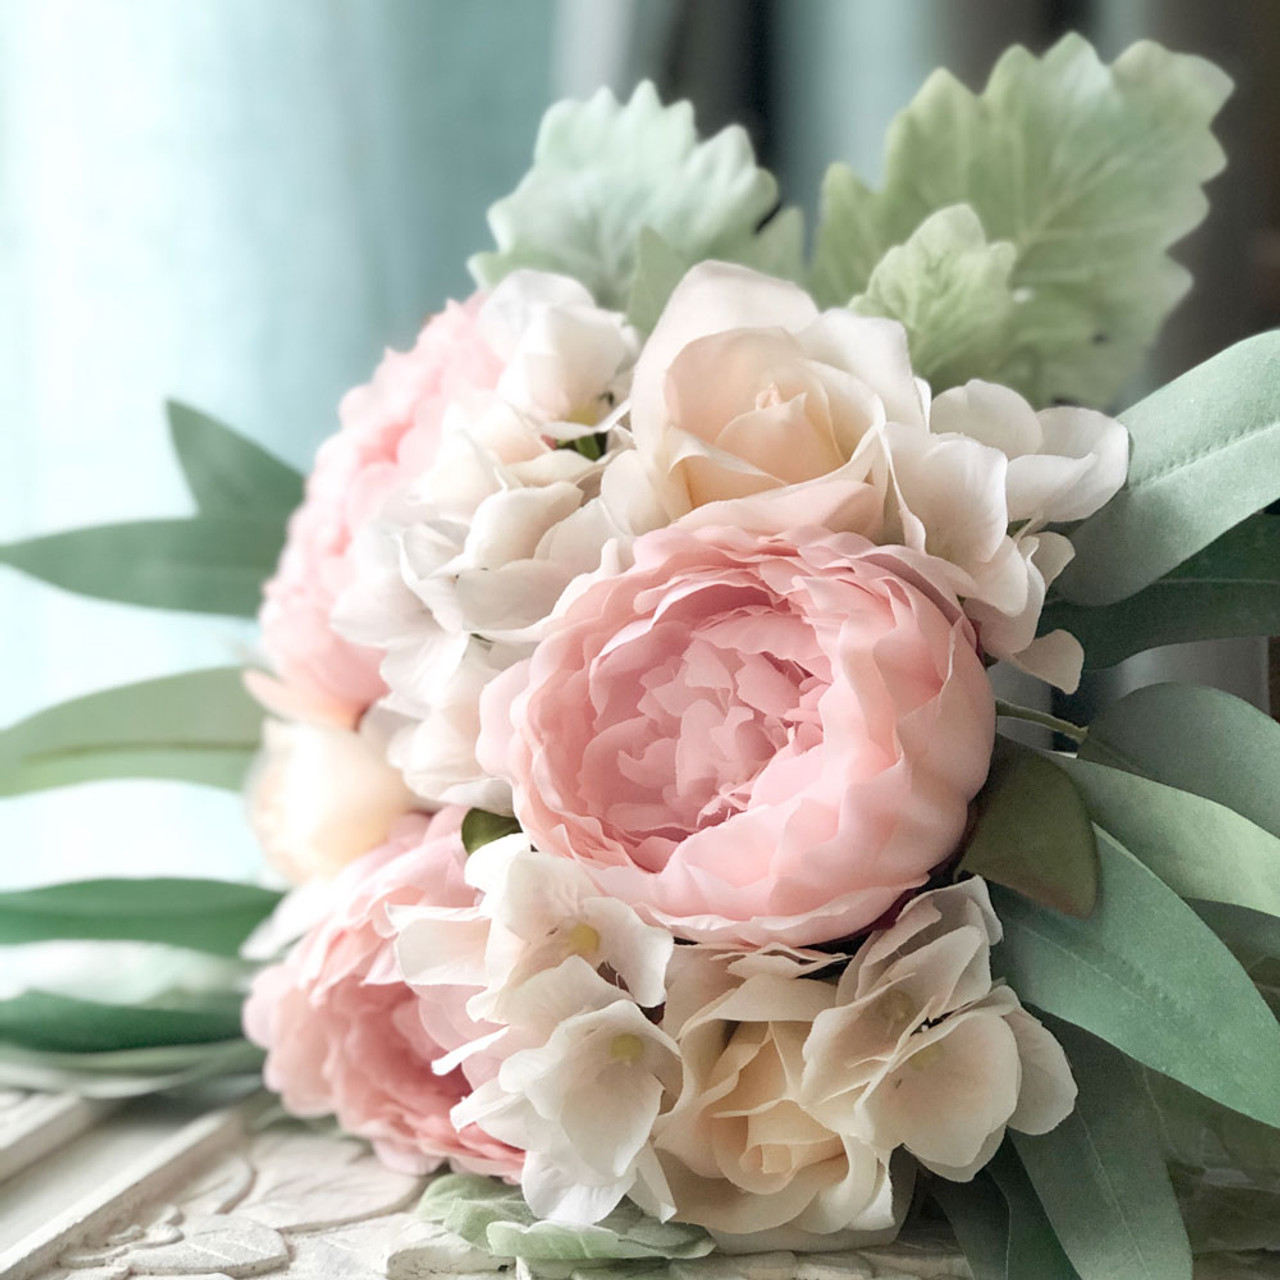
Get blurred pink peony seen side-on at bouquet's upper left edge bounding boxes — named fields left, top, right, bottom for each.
left=260, top=294, right=503, bottom=722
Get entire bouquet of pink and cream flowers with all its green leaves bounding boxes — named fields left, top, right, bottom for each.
left=0, top=37, right=1280, bottom=1280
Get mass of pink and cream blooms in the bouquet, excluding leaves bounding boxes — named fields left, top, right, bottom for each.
left=246, top=264, right=1128, bottom=1239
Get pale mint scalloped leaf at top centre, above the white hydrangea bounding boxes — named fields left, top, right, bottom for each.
left=470, top=82, right=788, bottom=308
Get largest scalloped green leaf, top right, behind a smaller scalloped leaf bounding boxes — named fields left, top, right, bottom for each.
left=813, top=36, right=1230, bottom=404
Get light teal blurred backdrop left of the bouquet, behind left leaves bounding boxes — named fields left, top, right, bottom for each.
left=0, top=0, right=554, bottom=883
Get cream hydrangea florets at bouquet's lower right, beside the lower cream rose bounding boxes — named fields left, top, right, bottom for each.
left=801, top=879, right=1075, bottom=1181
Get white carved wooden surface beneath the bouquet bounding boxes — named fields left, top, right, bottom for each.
left=0, top=1094, right=1280, bottom=1280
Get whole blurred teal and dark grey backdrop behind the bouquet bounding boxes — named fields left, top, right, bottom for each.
left=0, top=0, right=1280, bottom=886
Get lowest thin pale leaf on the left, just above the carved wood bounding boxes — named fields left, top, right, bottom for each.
left=0, top=1038, right=264, bottom=1098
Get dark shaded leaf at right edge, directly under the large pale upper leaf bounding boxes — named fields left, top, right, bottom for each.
left=1039, top=515, right=1280, bottom=669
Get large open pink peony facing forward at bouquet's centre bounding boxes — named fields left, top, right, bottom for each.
left=479, top=525, right=995, bottom=946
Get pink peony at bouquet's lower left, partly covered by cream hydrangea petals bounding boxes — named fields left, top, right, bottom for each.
left=244, top=809, right=521, bottom=1178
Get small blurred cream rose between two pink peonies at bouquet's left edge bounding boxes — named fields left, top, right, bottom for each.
left=248, top=719, right=417, bottom=884
